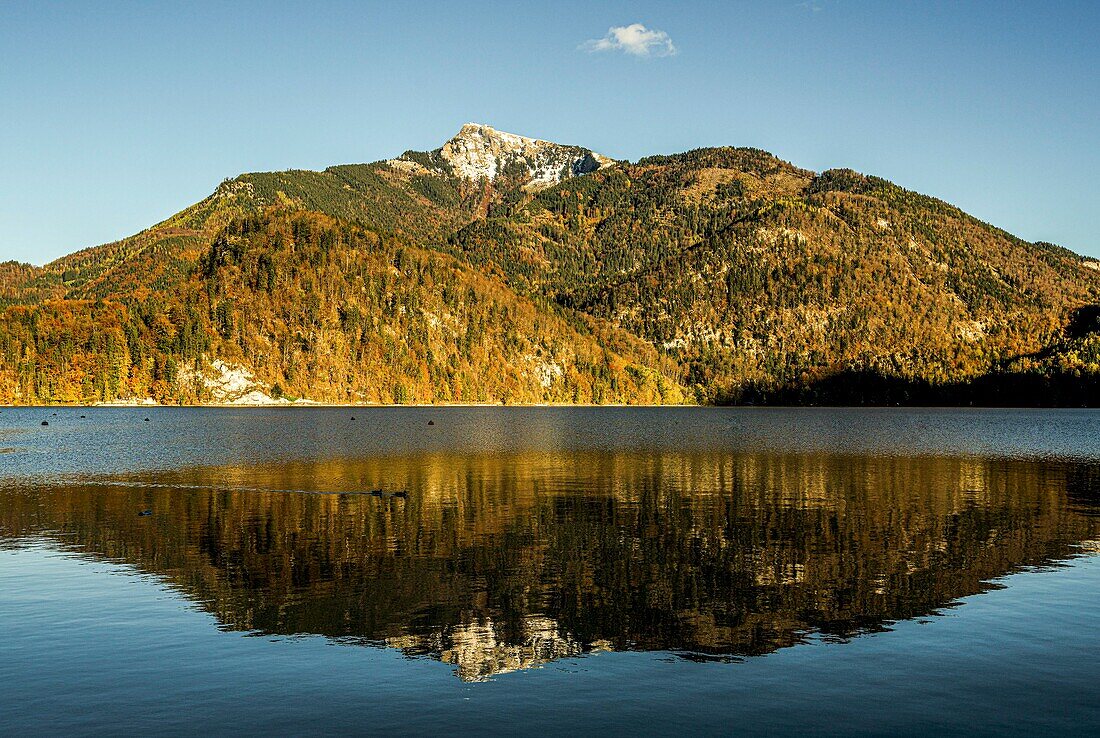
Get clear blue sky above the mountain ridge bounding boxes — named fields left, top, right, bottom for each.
left=0, top=0, right=1100, bottom=264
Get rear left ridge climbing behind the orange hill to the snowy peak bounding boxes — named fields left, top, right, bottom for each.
left=0, top=123, right=612, bottom=302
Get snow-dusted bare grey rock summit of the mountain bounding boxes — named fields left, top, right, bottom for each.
left=389, top=123, right=615, bottom=188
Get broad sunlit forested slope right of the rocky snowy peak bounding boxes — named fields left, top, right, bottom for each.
left=450, top=148, right=1100, bottom=399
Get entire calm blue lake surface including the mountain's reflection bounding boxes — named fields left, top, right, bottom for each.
left=0, top=408, right=1100, bottom=735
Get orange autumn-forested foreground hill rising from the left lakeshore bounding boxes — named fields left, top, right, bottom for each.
left=0, top=208, right=684, bottom=403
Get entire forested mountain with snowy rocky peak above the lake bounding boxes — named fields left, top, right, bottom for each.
left=0, top=123, right=1100, bottom=405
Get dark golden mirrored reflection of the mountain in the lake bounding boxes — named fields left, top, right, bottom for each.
left=0, top=451, right=1100, bottom=680
